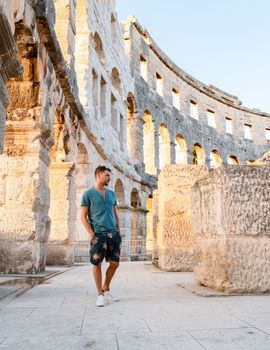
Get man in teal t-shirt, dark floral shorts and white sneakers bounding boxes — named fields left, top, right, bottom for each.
left=81, top=165, right=122, bottom=306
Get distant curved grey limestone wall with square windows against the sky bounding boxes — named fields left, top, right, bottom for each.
left=124, top=17, right=270, bottom=174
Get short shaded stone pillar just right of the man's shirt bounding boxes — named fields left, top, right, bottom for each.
left=130, top=208, right=147, bottom=260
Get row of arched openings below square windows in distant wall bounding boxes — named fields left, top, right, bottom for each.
left=127, top=98, right=239, bottom=171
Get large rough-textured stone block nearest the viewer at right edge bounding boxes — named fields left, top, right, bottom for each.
left=192, top=165, right=270, bottom=293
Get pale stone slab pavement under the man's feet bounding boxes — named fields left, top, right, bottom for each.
left=0, top=262, right=270, bottom=350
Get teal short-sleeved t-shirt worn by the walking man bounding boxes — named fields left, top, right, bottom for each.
left=81, top=187, right=118, bottom=233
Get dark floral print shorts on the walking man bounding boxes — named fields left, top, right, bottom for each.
left=90, top=232, right=122, bottom=265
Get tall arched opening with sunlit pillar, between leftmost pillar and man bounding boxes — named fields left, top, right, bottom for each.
left=46, top=108, right=77, bottom=265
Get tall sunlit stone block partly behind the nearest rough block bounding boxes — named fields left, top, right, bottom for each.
left=156, top=165, right=208, bottom=271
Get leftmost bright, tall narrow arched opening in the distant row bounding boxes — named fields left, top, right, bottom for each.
left=143, top=111, right=156, bottom=175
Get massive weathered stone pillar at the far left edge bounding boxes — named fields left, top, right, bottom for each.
left=0, top=121, right=50, bottom=273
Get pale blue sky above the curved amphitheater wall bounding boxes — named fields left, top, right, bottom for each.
left=116, top=0, right=270, bottom=113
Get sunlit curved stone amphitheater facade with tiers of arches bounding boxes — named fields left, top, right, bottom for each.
left=0, top=0, right=270, bottom=288
